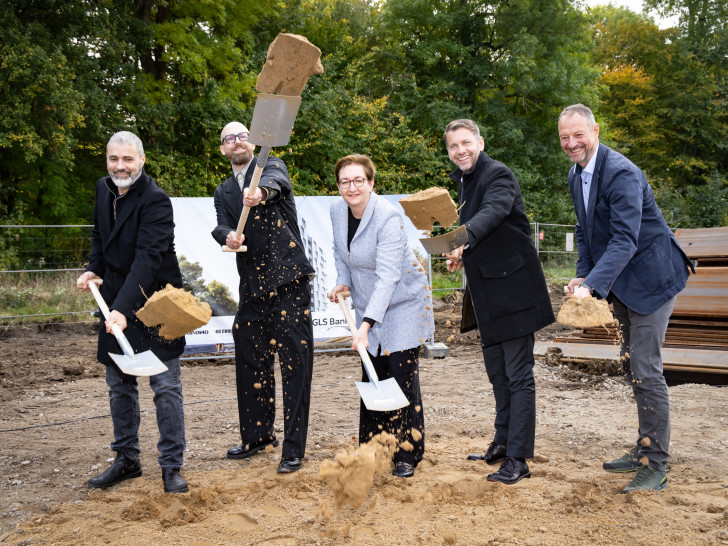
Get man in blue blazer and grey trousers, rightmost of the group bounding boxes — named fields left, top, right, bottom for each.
left=558, top=104, right=692, bottom=493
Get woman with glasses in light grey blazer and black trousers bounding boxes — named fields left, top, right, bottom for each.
left=330, top=155, right=433, bottom=478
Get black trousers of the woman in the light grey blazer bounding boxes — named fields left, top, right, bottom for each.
left=359, top=347, right=425, bottom=466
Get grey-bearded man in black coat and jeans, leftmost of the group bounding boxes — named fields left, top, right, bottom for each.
left=76, top=131, right=188, bottom=493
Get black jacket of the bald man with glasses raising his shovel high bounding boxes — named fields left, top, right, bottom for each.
left=212, top=157, right=314, bottom=301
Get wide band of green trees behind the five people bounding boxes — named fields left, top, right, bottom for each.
left=0, top=0, right=728, bottom=230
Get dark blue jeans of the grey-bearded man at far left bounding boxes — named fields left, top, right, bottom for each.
left=106, top=358, right=186, bottom=468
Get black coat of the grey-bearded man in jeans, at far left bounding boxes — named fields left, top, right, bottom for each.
left=86, top=171, right=185, bottom=364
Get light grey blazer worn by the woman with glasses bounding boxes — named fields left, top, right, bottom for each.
left=330, top=192, right=434, bottom=356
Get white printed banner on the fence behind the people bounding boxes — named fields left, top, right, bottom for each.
left=172, top=195, right=427, bottom=354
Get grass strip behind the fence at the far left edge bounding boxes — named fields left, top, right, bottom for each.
left=0, top=271, right=96, bottom=324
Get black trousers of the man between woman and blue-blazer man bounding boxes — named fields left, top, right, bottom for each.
left=483, top=334, right=536, bottom=459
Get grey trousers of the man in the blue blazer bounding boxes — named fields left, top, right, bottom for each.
left=612, top=297, right=675, bottom=471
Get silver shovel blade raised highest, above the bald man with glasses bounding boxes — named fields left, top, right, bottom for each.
left=248, top=93, right=301, bottom=148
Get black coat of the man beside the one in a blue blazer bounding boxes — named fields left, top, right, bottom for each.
left=450, top=152, right=554, bottom=345
